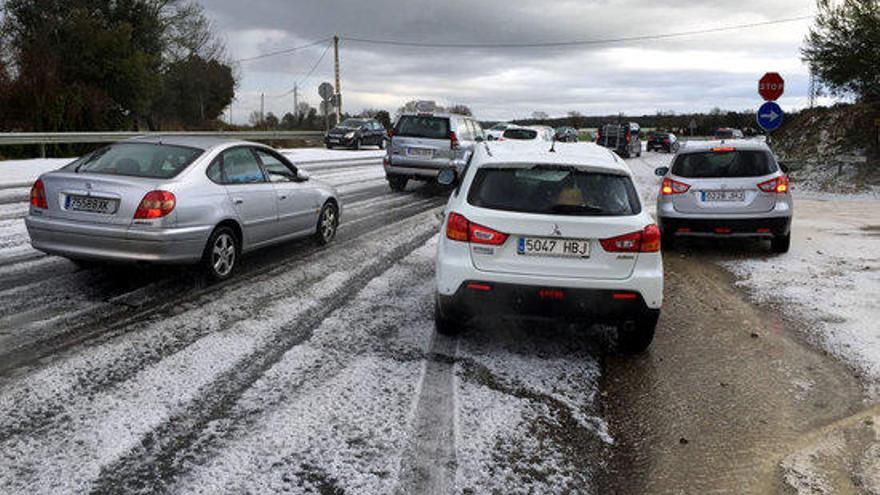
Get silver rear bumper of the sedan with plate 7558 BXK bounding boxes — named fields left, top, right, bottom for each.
left=25, top=216, right=211, bottom=263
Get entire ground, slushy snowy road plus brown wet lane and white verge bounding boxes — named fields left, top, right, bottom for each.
left=0, top=145, right=880, bottom=494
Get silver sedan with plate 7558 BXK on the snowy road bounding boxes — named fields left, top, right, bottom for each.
left=25, top=136, right=341, bottom=280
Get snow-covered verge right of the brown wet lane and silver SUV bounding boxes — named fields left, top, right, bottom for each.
left=722, top=195, right=880, bottom=397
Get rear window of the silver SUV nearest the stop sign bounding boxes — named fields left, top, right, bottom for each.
left=672, top=150, right=776, bottom=179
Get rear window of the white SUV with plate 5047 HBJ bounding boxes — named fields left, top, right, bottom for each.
left=467, top=165, right=641, bottom=216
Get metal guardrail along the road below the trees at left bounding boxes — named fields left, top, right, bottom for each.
left=0, top=131, right=324, bottom=158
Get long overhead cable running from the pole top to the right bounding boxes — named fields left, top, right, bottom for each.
left=342, top=15, right=813, bottom=48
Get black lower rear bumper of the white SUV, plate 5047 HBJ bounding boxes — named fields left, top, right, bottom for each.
left=437, top=280, right=660, bottom=323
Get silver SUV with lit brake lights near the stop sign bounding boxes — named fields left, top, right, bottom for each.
left=655, top=140, right=793, bottom=253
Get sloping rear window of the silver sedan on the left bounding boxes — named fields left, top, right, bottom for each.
left=64, top=143, right=204, bottom=179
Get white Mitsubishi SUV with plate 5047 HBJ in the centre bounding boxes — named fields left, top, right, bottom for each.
left=435, top=143, right=663, bottom=352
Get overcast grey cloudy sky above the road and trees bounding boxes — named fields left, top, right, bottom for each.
left=203, top=0, right=815, bottom=122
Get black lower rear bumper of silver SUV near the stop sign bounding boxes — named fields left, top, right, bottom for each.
left=657, top=217, right=791, bottom=237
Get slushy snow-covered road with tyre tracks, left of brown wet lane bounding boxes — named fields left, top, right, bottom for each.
left=0, top=151, right=610, bottom=494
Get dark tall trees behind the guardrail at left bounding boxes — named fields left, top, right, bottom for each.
left=0, top=0, right=236, bottom=132
